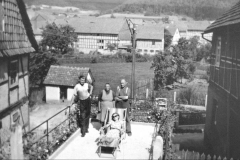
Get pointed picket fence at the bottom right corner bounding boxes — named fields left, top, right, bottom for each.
left=176, top=150, right=234, bottom=160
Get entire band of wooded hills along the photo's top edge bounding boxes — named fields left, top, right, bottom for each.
left=24, top=0, right=239, bottom=20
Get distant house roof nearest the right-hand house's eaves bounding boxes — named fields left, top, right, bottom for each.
left=187, top=21, right=211, bottom=31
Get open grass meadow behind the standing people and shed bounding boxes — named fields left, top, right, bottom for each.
left=62, top=62, right=154, bottom=94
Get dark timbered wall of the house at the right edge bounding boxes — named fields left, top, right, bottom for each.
left=205, top=25, right=240, bottom=158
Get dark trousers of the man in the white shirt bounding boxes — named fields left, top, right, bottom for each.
left=77, top=97, right=91, bottom=134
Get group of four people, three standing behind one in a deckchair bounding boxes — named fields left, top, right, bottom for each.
left=71, top=75, right=132, bottom=137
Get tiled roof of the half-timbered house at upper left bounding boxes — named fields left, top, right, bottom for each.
left=0, top=0, right=35, bottom=57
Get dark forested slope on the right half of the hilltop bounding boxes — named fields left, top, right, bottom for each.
left=114, top=0, right=239, bottom=20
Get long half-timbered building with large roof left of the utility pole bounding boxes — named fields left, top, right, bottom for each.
left=56, top=17, right=131, bottom=54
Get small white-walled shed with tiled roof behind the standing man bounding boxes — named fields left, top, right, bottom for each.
left=44, top=65, right=94, bottom=102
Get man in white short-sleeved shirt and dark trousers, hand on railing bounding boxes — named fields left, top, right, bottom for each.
left=71, top=75, right=93, bottom=137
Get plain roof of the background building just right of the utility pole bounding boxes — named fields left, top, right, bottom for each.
left=136, top=25, right=164, bottom=40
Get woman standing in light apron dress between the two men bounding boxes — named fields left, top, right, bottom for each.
left=98, top=83, right=115, bottom=125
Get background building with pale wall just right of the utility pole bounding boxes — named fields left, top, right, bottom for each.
left=136, top=25, right=164, bottom=55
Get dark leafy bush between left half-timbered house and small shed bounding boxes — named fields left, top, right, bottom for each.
left=29, top=52, right=57, bottom=86
